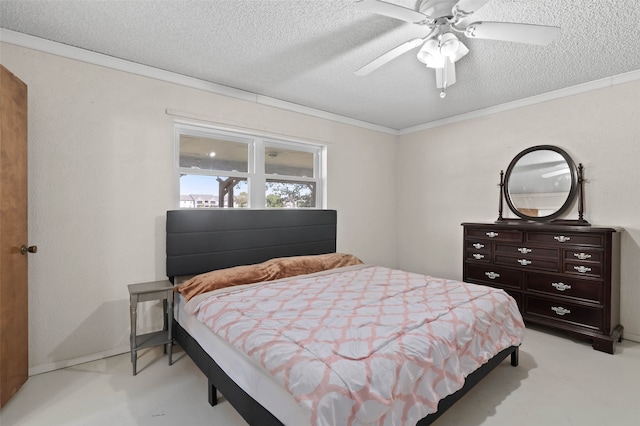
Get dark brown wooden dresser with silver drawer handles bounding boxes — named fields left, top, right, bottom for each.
left=462, top=221, right=623, bottom=354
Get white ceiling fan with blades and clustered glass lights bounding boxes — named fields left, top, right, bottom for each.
left=355, top=0, right=560, bottom=98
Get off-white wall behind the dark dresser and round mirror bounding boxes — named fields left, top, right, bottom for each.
left=398, top=81, right=640, bottom=341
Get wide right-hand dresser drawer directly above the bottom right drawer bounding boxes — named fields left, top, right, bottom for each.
left=525, top=272, right=604, bottom=304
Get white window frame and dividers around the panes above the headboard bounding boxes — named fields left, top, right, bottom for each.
left=174, top=121, right=326, bottom=209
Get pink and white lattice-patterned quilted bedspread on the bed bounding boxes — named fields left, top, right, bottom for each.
left=187, top=265, right=524, bottom=426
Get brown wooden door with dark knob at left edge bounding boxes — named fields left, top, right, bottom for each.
left=0, top=65, right=29, bottom=407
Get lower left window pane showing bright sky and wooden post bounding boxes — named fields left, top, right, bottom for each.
left=180, top=174, right=249, bottom=208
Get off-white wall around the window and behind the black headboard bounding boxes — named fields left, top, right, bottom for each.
left=0, top=43, right=396, bottom=374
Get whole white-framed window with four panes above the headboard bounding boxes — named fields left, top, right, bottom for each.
left=175, top=123, right=323, bottom=208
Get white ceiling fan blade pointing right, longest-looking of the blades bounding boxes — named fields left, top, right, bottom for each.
left=464, top=22, right=560, bottom=46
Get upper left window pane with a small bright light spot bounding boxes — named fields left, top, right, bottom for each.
left=180, top=135, right=249, bottom=172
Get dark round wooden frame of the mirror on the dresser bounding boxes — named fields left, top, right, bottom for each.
left=500, top=145, right=582, bottom=222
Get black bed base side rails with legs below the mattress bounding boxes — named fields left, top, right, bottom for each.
left=173, top=320, right=519, bottom=426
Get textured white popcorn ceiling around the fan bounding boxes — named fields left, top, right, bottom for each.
left=0, top=0, right=640, bottom=129
